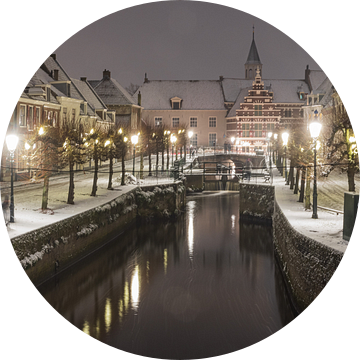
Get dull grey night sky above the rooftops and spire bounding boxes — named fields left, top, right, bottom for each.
left=53, top=0, right=321, bottom=87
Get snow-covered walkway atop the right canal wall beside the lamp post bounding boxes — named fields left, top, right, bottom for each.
left=273, top=168, right=349, bottom=253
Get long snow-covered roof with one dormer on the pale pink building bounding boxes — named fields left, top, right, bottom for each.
left=134, top=80, right=225, bottom=110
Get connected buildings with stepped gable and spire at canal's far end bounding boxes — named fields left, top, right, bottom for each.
left=135, top=31, right=327, bottom=153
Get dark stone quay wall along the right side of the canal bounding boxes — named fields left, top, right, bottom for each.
left=239, top=183, right=345, bottom=314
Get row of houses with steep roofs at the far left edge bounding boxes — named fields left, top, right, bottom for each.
left=0, top=54, right=115, bottom=181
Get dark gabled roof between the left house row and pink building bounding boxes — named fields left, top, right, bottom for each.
left=89, top=77, right=136, bottom=105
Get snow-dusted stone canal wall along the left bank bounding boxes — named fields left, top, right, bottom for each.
left=10, top=182, right=186, bottom=285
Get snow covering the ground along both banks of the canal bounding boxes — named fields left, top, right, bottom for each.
left=2, top=154, right=360, bottom=252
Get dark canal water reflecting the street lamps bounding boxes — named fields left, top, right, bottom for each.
left=37, top=192, right=296, bottom=360
